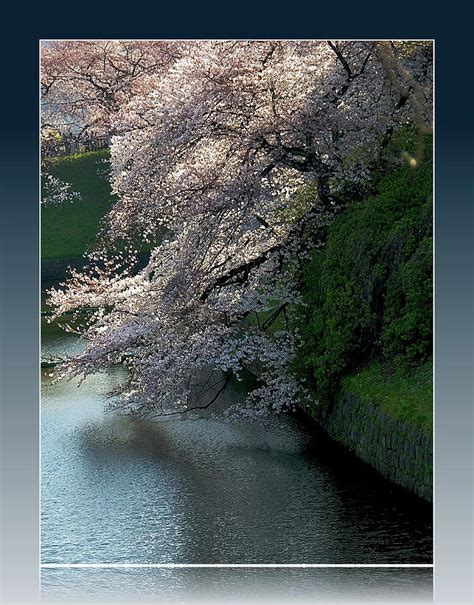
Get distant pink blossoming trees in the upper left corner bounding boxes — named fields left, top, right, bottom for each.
left=41, top=40, right=181, bottom=137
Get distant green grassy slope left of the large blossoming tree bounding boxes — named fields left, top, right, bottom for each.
left=41, top=150, right=115, bottom=259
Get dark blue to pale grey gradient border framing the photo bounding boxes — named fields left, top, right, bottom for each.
left=0, top=7, right=474, bottom=603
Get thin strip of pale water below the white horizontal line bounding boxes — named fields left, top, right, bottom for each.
left=42, top=568, right=433, bottom=604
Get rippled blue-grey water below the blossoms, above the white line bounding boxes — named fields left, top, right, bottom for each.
left=41, top=306, right=432, bottom=600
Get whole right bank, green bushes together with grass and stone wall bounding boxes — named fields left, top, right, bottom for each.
left=294, top=137, right=433, bottom=501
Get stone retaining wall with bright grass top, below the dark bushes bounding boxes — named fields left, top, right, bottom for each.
left=298, top=364, right=433, bottom=503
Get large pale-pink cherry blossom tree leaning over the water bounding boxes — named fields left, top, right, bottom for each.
left=45, top=41, right=432, bottom=416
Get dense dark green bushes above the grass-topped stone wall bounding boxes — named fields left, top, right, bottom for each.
left=296, top=142, right=432, bottom=401
